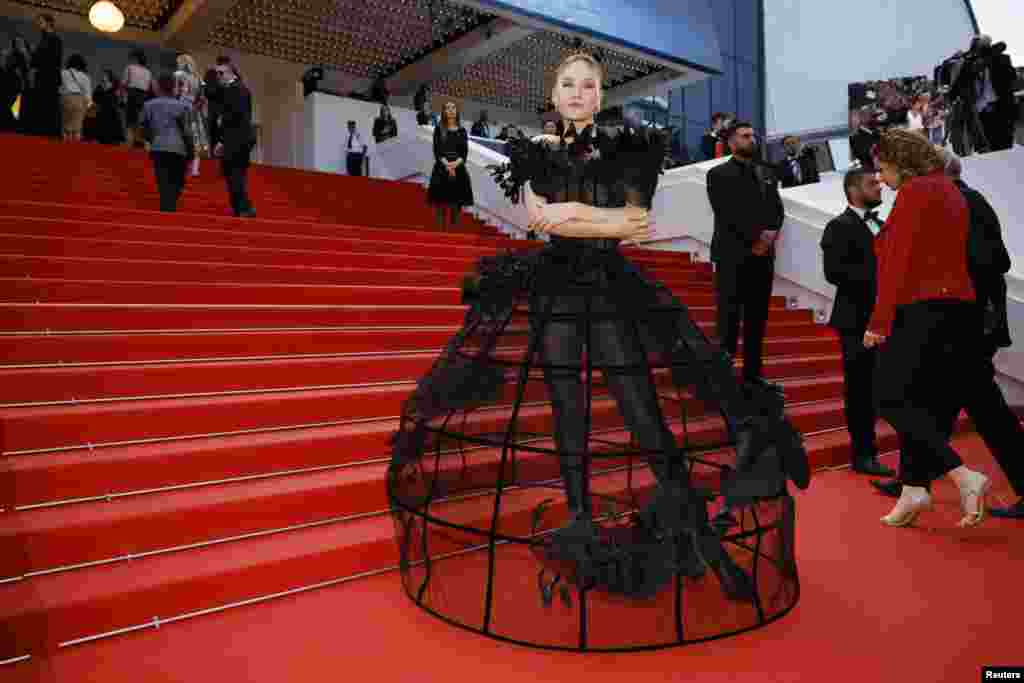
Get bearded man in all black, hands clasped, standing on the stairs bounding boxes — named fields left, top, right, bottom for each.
left=708, top=122, right=785, bottom=391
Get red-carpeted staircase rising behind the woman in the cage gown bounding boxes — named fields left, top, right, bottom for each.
left=0, top=132, right=913, bottom=660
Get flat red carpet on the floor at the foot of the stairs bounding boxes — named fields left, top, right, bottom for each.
left=5, top=437, right=1024, bottom=683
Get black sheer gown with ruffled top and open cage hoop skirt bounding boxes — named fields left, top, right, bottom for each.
left=388, top=128, right=809, bottom=650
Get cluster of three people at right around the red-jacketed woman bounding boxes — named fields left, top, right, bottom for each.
left=821, top=128, right=1024, bottom=526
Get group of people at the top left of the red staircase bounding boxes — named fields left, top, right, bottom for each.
left=0, top=14, right=256, bottom=217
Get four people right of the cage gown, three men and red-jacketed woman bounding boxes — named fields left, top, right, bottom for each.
left=708, top=122, right=1024, bottom=526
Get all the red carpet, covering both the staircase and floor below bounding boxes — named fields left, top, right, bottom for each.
left=0, top=137, right=1019, bottom=683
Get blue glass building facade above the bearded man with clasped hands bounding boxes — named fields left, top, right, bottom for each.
left=668, top=0, right=765, bottom=162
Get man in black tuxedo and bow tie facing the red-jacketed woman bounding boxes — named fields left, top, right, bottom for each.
left=821, top=169, right=893, bottom=476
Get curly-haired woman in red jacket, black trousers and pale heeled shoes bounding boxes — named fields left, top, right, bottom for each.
left=864, top=129, right=990, bottom=526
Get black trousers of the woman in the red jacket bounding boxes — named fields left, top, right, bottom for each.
left=876, top=300, right=981, bottom=486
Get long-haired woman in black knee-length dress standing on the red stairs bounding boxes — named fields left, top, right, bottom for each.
left=427, top=102, right=473, bottom=229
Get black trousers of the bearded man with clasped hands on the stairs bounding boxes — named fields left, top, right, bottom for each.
left=715, top=255, right=775, bottom=379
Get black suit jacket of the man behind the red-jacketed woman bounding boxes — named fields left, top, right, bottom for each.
left=956, top=180, right=1012, bottom=351
